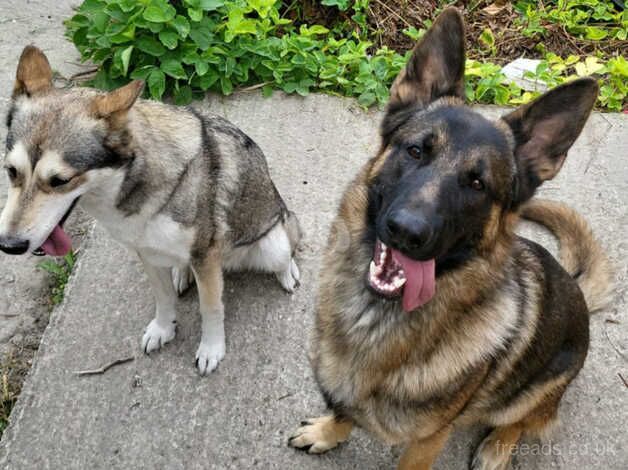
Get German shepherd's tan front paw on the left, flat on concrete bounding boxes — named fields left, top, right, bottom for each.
left=288, top=416, right=352, bottom=454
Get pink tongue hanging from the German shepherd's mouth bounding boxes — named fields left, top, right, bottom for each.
left=391, top=250, right=436, bottom=312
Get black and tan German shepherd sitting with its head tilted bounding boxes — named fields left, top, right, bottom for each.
left=290, top=8, right=612, bottom=470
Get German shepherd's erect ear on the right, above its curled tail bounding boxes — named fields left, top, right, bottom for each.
left=502, top=78, right=598, bottom=204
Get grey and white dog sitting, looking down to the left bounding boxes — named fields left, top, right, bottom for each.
left=0, top=46, right=300, bottom=374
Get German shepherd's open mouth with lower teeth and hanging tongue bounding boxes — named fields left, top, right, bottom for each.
left=368, top=240, right=436, bottom=312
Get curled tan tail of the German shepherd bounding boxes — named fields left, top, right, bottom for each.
left=521, top=199, right=614, bottom=312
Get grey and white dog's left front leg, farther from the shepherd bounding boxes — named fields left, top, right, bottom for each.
left=138, top=253, right=177, bottom=354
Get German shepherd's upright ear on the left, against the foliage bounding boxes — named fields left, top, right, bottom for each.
left=389, top=7, right=465, bottom=107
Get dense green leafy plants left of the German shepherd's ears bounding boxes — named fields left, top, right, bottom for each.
left=66, top=0, right=402, bottom=106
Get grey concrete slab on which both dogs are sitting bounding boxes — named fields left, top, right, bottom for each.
left=0, top=93, right=628, bottom=470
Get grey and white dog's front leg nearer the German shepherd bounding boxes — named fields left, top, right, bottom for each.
left=192, top=249, right=225, bottom=375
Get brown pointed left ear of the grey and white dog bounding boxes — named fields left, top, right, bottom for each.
left=13, top=46, right=52, bottom=98
